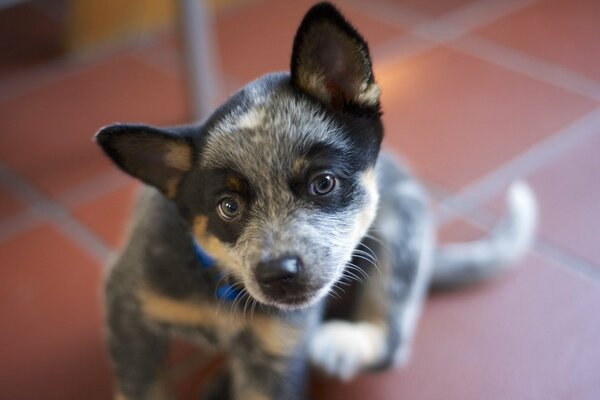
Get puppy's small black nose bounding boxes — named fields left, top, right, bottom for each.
left=256, top=255, right=302, bottom=296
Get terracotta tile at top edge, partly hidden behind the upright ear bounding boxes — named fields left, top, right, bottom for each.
left=217, top=0, right=402, bottom=82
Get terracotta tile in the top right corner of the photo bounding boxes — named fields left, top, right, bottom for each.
left=477, top=0, right=600, bottom=80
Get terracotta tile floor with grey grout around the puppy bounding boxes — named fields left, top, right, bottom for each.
left=0, top=0, right=600, bottom=400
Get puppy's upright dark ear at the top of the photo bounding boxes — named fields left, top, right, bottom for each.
left=291, top=3, right=380, bottom=109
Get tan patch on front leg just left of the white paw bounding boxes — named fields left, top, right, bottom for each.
left=251, top=316, right=302, bottom=357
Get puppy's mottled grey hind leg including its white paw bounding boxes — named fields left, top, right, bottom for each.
left=310, top=172, right=433, bottom=379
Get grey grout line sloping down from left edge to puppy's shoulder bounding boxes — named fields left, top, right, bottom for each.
left=0, top=162, right=111, bottom=265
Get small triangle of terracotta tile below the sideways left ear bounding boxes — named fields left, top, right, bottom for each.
left=73, top=179, right=140, bottom=248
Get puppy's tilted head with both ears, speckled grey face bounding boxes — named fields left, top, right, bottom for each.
left=96, top=3, right=383, bottom=308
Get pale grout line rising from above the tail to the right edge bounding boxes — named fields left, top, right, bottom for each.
left=444, top=107, right=600, bottom=212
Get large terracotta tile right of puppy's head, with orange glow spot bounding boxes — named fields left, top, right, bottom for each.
left=375, top=47, right=596, bottom=190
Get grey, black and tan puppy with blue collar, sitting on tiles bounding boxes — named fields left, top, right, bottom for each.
left=96, top=3, right=536, bottom=400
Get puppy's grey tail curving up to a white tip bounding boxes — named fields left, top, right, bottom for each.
left=432, top=181, right=537, bottom=288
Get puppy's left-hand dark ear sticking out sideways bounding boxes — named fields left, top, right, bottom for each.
left=95, top=124, right=193, bottom=198
